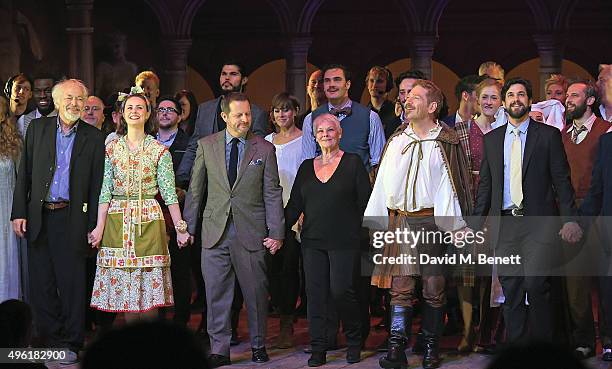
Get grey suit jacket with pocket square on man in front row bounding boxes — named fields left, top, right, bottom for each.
left=183, top=130, right=285, bottom=251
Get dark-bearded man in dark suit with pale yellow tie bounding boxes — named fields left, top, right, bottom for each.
left=468, top=78, right=581, bottom=343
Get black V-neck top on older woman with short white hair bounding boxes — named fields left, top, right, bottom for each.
left=286, top=152, right=372, bottom=250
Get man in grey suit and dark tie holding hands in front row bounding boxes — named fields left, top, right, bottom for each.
left=184, top=93, right=285, bottom=367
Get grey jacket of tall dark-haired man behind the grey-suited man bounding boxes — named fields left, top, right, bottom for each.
left=176, top=97, right=271, bottom=186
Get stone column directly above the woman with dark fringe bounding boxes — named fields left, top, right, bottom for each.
left=285, top=35, right=312, bottom=107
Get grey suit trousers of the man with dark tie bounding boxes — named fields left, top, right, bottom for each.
left=202, top=217, right=268, bottom=357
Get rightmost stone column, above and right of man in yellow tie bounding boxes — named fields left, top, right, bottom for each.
left=533, top=33, right=565, bottom=99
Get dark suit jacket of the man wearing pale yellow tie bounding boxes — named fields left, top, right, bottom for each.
left=468, top=120, right=577, bottom=245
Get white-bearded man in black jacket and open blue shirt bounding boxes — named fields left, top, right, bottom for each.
left=11, top=79, right=104, bottom=361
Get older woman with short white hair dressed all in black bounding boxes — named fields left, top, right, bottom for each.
left=286, top=114, right=371, bottom=366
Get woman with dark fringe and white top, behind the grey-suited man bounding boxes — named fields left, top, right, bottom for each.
left=266, top=92, right=302, bottom=348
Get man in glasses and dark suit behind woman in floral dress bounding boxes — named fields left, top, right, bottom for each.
left=156, top=96, right=191, bottom=326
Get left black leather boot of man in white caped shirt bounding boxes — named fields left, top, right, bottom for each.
left=378, top=305, right=412, bottom=369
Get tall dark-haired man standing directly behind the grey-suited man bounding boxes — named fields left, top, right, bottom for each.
left=176, top=61, right=271, bottom=184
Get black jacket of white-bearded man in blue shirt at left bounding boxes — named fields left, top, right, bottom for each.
left=11, top=117, right=104, bottom=255
